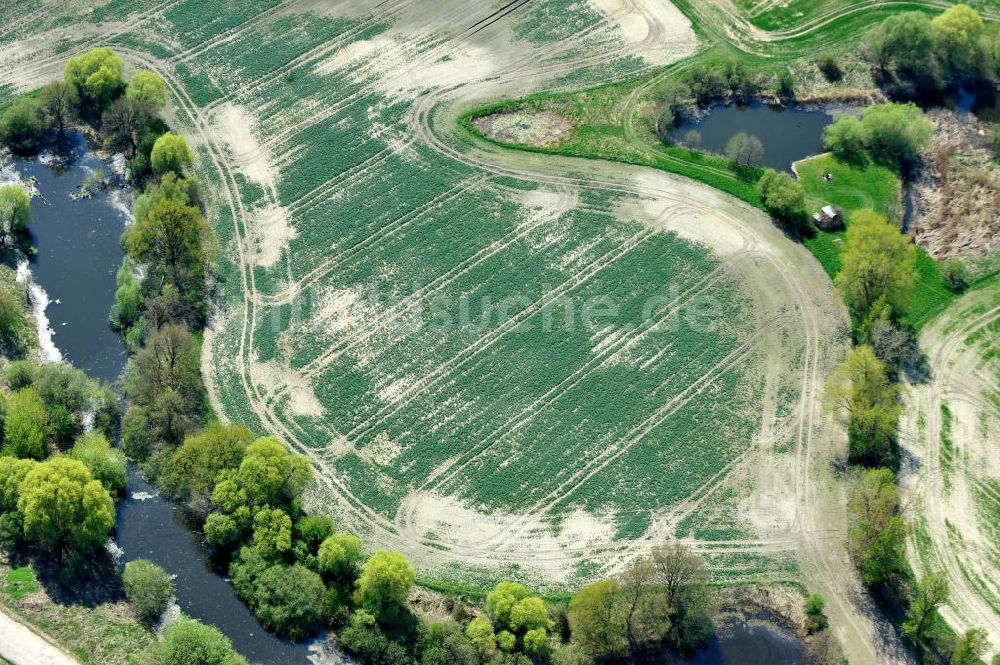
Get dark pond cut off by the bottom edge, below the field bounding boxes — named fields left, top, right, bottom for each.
left=684, top=619, right=806, bottom=665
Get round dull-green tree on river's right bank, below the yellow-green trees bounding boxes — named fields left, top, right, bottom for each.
left=253, top=564, right=326, bottom=640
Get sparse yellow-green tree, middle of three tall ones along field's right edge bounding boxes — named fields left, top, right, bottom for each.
left=826, top=344, right=902, bottom=465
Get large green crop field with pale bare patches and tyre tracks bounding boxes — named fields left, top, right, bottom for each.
left=4, top=0, right=843, bottom=588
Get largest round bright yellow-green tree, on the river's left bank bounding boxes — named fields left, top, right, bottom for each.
left=17, top=457, right=115, bottom=552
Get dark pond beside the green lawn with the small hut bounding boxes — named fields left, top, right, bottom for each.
left=665, top=102, right=833, bottom=171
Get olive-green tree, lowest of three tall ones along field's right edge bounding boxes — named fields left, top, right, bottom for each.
left=848, top=469, right=907, bottom=586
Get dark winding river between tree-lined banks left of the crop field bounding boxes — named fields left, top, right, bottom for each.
left=0, top=134, right=338, bottom=664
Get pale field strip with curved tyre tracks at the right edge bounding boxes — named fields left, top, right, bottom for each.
left=901, top=287, right=1000, bottom=652
